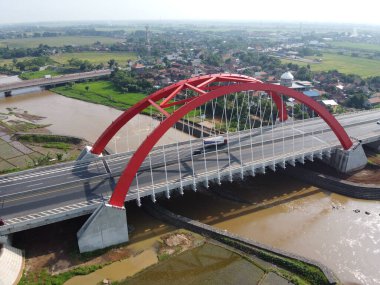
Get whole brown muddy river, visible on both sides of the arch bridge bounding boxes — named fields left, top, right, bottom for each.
left=0, top=92, right=380, bottom=284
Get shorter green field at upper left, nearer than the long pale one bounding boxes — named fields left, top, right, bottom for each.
left=51, top=52, right=137, bottom=66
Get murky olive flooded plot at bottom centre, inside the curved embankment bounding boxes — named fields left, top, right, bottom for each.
left=113, top=241, right=296, bottom=285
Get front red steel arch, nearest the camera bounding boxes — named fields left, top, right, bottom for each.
left=109, top=82, right=352, bottom=207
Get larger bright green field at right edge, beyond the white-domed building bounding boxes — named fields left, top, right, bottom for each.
left=281, top=53, right=380, bottom=77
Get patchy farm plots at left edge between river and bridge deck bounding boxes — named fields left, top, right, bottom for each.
left=0, top=107, right=88, bottom=174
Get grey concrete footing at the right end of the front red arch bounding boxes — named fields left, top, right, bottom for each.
left=329, top=142, right=367, bottom=173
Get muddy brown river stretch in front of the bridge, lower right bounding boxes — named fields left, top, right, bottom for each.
left=160, top=173, right=380, bottom=284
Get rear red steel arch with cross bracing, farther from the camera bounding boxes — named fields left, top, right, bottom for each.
left=91, top=73, right=288, bottom=154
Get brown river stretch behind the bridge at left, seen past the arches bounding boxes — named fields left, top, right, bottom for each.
left=0, top=91, right=189, bottom=153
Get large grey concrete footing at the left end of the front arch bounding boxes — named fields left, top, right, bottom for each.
left=77, top=204, right=129, bottom=252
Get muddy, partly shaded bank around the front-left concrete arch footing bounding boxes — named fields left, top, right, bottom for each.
left=13, top=203, right=211, bottom=285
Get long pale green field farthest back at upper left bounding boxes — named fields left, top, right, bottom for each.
left=0, top=36, right=123, bottom=48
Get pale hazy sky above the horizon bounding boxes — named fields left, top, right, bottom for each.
left=0, top=0, right=380, bottom=25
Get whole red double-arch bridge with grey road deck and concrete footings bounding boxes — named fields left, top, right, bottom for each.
left=0, top=74, right=380, bottom=251
